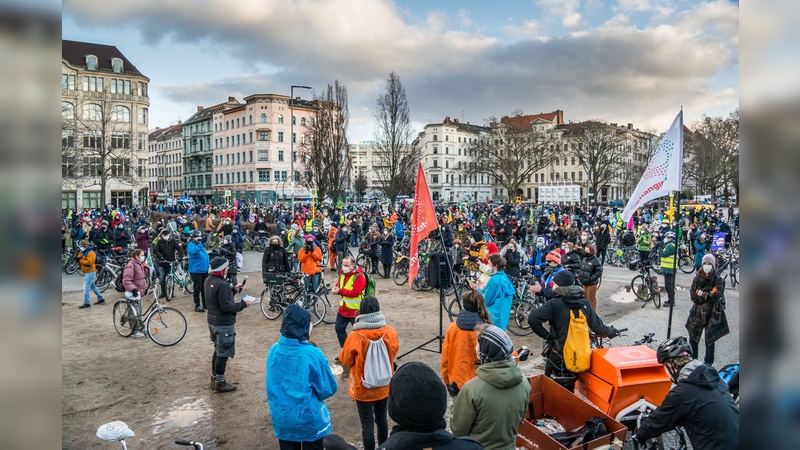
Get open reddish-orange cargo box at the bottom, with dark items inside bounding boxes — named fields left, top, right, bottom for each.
left=516, top=375, right=628, bottom=450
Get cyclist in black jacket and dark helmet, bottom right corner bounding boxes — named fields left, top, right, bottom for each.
left=633, top=336, right=739, bottom=450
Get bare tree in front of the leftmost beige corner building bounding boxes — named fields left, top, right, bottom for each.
left=61, top=96, right=141, bottom=205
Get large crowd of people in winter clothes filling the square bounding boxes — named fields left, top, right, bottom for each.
left=62, top=203, right=738, bottom=449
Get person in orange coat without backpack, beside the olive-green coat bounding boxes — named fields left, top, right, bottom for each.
left=442, top=289, right=492, bottom=397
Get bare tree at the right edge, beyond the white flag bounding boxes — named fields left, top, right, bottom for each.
left=683, top=109, right=739, bottom=201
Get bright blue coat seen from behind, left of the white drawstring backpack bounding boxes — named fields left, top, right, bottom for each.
left=266, top=334, right=338, bottom=442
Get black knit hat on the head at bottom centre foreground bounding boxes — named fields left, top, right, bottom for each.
left=388, top=362, right=447, bottom=432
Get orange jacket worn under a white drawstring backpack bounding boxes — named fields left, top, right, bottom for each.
left=339, top=325, right=400, bottom=402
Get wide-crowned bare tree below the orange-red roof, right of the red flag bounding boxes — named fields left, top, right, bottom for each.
left=467, top=117, right=556, bottom=198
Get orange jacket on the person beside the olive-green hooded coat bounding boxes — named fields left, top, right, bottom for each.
left=442, top=322, right=478, bottom=389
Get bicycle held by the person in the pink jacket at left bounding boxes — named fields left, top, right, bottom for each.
left=112, top=285, right=186, bottom=347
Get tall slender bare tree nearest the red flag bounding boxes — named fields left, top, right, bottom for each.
left=372, top=72, right=420, bottom=208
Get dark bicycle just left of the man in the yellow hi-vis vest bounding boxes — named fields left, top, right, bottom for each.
left=261, top=273, right=326, bottom=326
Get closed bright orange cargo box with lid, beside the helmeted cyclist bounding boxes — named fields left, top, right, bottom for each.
left=575, top=345, right=672, bottom=417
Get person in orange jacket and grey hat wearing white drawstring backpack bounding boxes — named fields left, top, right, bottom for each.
left=339, top=296, right=400, bottom=449
